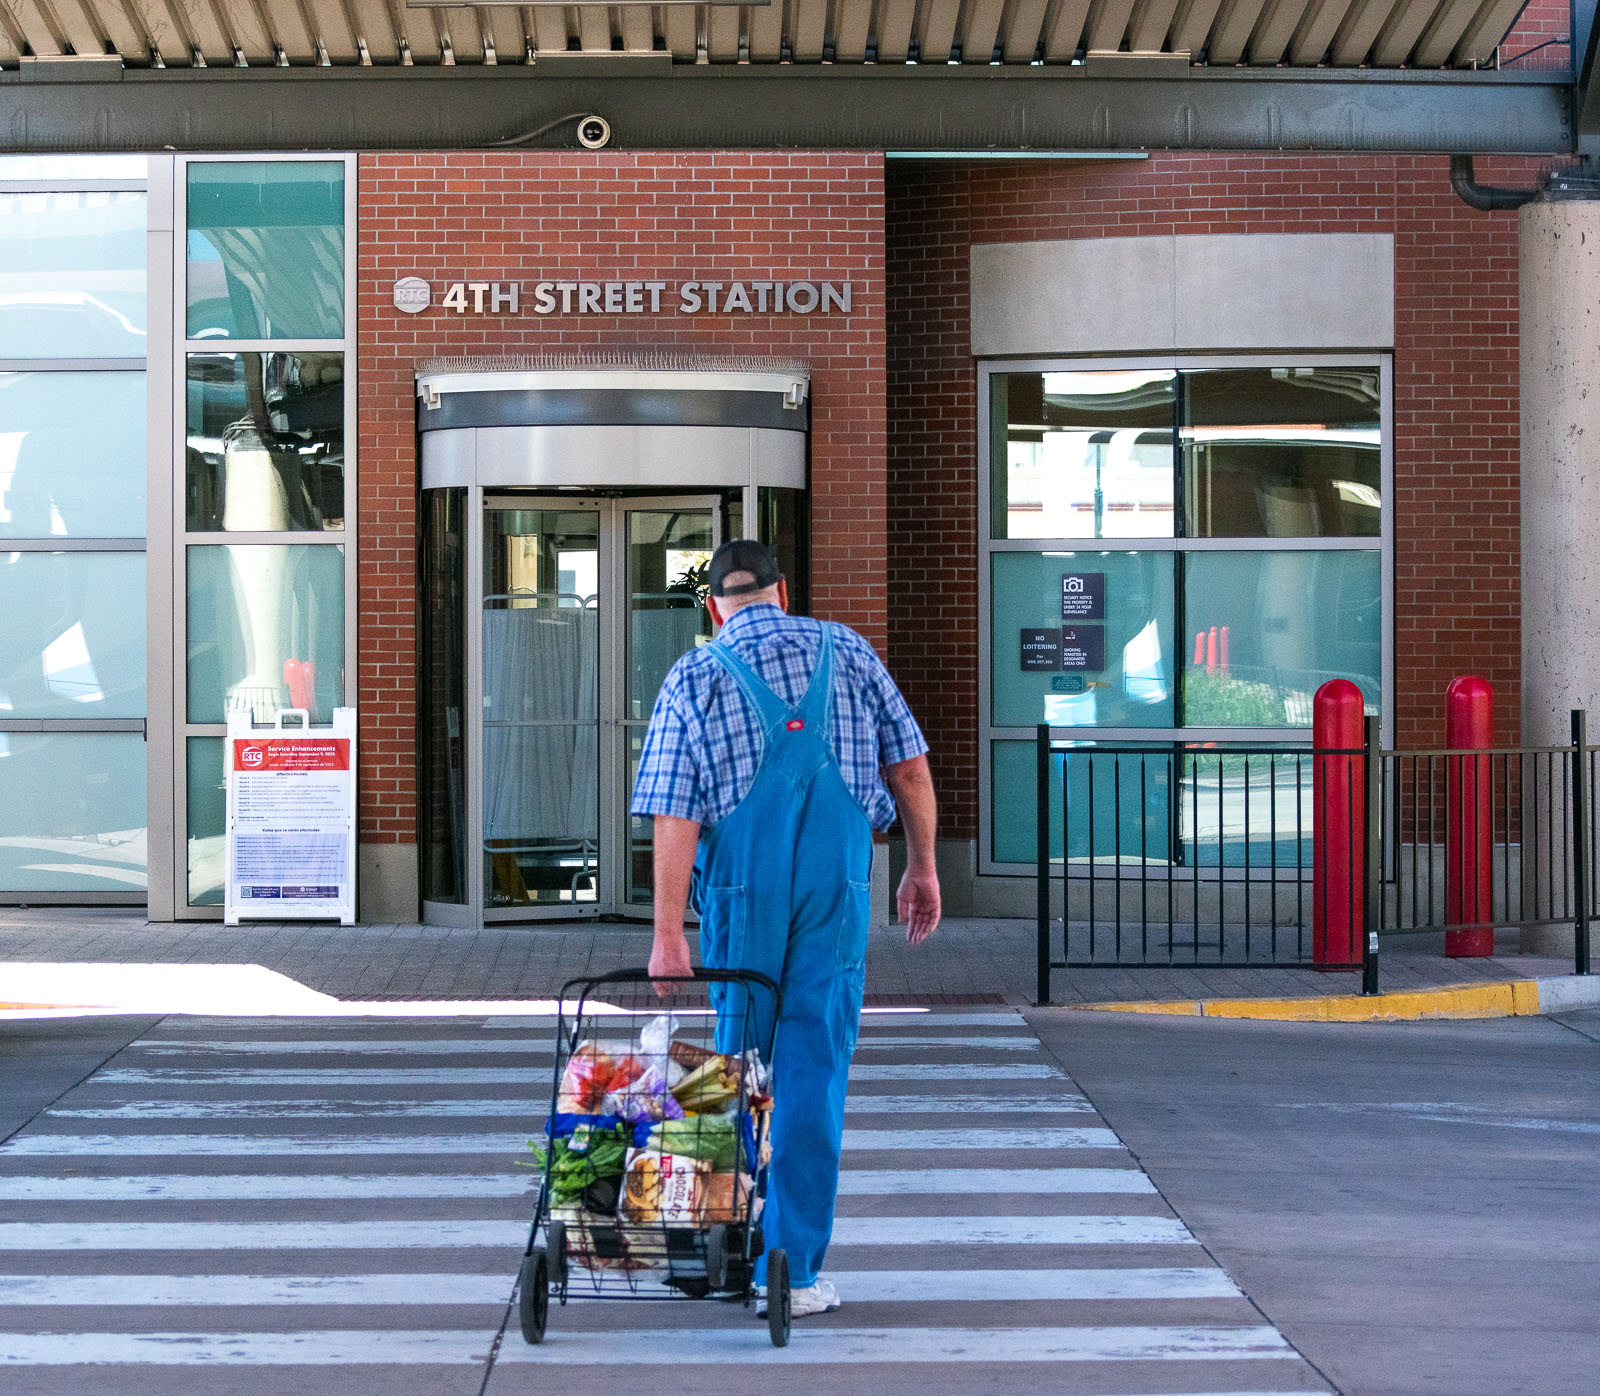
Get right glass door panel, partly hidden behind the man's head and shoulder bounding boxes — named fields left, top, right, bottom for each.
left=618, top=496, right=718, bottom=906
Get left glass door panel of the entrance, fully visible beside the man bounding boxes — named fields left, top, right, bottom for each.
left=483, top=506, right=605, bottom=911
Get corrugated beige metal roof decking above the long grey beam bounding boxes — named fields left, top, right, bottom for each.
left=0, top=0, right=1525, bottom=69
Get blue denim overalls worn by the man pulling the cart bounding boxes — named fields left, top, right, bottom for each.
left=694, top=623, right=872, bottom=1289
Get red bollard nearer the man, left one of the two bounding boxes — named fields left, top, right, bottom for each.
left=1310, top=679, right=1366, bottom=970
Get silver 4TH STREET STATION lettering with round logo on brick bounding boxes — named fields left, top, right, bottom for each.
left=395, top=277, right=851, bottom=315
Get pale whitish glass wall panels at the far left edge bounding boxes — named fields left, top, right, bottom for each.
left=0, top=155, right=149, bottom=901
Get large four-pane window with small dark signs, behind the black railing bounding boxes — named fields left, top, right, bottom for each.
left=981, top=355, right=1389, bottom=868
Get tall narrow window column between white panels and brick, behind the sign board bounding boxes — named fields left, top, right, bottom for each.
left=174, top=157, right=355, bottom=906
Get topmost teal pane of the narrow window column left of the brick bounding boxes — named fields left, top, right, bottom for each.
left=187, top=160, right=344, bottom=339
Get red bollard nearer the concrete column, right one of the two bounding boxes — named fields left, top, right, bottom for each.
left=1445, top=674, right=1494, bottom=959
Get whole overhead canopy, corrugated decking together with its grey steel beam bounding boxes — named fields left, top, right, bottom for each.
left=0, top=0, right=1580, bottom=154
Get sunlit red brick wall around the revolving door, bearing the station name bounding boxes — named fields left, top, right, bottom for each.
left=357, top=150, right=888, bottom=844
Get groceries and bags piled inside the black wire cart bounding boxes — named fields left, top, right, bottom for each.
left=530, top=1013, right=771, bottom=1282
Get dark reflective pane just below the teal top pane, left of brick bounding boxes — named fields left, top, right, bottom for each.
left=186, top=354, right=344, bottom=532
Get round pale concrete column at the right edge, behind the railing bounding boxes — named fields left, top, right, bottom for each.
left=1518, top=189, right=1600, bottom=954
